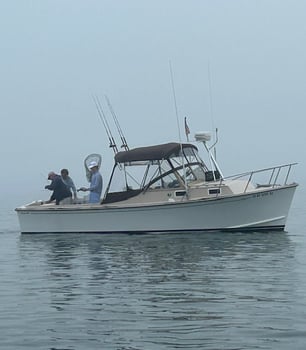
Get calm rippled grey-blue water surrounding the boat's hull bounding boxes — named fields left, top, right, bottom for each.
left=0, top=195, right=306, bottom=350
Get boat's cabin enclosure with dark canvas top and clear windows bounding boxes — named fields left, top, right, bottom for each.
left=102, top=142, right=220, bottom=204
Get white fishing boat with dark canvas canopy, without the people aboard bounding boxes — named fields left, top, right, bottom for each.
left=15, top=132, right=298, bottom=233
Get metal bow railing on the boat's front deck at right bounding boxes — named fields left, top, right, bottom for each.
left=220, top=163, right=298, bottom=193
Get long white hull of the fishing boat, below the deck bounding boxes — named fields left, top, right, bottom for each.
left=16, top=184, right=297, bottom=233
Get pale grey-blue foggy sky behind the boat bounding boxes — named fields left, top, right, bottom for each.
left=0, top=0, right=306, bottom=205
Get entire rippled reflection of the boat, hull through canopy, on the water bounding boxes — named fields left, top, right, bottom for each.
left=19, top=232, right=295, bottom=329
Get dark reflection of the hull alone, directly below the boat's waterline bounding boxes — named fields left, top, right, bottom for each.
left=19, top=232, right=294, bottom=271
